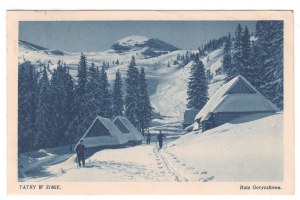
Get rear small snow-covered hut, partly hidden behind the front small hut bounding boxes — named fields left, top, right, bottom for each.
left=113, top=116, right=144, bottom=145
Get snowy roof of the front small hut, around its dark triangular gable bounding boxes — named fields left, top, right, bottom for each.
left=76, top=116, right=128, bottom=147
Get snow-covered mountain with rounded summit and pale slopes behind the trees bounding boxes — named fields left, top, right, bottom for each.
left=19, top=35, right=224, bottom=123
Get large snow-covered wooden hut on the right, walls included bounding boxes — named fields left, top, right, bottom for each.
left=195, top=76, right=278, bottom=131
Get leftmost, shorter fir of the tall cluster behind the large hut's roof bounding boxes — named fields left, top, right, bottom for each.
left=222, top=33, right=234, bottom=76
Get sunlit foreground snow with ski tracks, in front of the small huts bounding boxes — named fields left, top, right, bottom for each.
left=24, top=141, right=214, bottom=182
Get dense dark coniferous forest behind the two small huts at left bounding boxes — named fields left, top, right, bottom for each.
left=18, top=54, right=152, bottom=152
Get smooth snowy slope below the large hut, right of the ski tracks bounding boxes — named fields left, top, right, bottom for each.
left=168, top=114, right=283, bottom=181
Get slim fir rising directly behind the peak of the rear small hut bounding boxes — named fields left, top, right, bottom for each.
left=112, top=70, right=124, bottom=116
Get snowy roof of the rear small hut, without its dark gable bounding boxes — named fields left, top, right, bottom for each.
left=113, top=116, right=143, bottom=141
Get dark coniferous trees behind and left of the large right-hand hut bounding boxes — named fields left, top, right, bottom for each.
left=187, top=21, right=284, bottom=110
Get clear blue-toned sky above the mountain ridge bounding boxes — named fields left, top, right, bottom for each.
left=19, top=21, right=255, bottom=52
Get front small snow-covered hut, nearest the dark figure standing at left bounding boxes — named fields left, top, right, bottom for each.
left=75, top=116, right=128, bottom=153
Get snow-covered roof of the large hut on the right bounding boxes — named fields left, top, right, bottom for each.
left=195, top=76, right=278, bottom=121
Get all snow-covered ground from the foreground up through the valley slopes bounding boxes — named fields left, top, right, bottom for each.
left=19, top=37, right=283, bottom=182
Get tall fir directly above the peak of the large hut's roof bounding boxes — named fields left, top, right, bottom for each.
left=232, top=24, right=242, bottom=75
